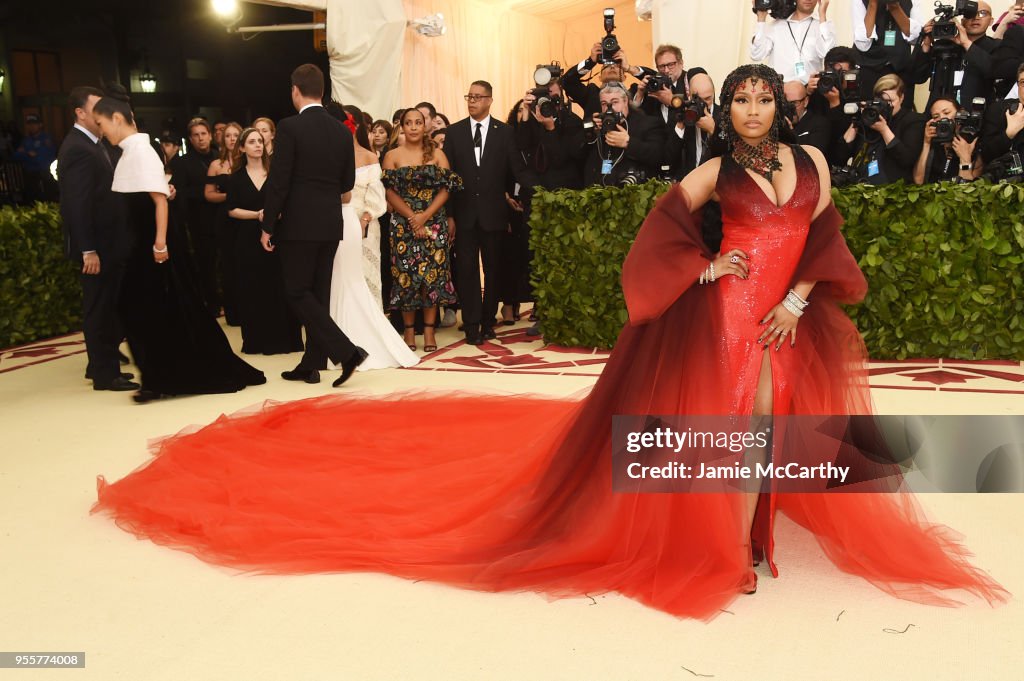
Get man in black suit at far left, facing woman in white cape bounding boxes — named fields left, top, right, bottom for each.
left=57, top=87, right=139, bottom=390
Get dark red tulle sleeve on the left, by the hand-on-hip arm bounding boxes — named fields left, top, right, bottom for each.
left=623, top=185, right=712, bottom=325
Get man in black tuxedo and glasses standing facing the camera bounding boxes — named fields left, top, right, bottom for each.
left=444, top=81, right=523, bottom=345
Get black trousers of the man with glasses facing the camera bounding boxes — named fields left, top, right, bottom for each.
left=455, top=222, right=508, bottom=335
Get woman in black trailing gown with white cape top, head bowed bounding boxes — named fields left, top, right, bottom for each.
left=93, top=88, right=266, bottom=402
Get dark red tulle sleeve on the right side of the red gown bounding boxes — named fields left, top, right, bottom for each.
left=793, top=203, right=867, bottom=304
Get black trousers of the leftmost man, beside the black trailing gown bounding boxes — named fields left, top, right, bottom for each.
left=79, top=258, right=125, bottom=385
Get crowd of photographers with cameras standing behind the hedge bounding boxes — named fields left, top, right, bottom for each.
left=509, top=0, right=1024, bottom=188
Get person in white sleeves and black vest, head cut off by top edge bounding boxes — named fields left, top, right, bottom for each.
left=850, top=0, right=925, bottom=101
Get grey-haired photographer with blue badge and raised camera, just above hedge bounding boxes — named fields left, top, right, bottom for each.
left=584, top=83, right=665, bottom=186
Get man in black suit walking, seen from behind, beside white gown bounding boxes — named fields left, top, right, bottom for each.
left=260, top=63, right=367, bottom=387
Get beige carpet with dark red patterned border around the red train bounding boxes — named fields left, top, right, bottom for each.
left=0, top=315, right=1024, bottom=681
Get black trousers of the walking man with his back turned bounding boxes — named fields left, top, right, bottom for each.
left=278, top=241, right=355, bottom=371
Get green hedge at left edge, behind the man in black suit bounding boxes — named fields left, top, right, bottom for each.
left=0, top=204, right=82, bottom=348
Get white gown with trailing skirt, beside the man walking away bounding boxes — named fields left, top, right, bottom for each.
left=331, top=165, right=420, bottom=371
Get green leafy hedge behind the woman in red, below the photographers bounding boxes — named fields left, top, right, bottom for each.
left=530, top=181, right=1024, bottom=359
